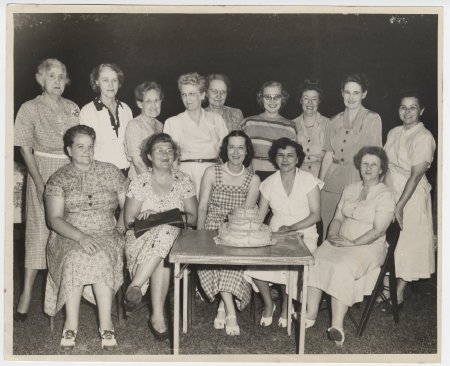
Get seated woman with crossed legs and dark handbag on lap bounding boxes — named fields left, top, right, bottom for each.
left=124, top=133, right=197, bottom=340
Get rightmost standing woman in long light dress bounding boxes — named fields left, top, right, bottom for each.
left=384, top=92, right=436, bottom=305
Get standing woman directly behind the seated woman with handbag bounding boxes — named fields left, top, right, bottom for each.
left=124, top=81, right=164, bottom=179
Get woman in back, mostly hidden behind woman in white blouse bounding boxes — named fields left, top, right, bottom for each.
left=205, top=74, right=244, bottom=131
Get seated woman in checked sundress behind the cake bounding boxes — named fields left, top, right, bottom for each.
left=197, top=130, right=259, bottom=336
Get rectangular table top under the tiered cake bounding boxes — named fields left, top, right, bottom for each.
left=169, top=230, right=314, bottom=265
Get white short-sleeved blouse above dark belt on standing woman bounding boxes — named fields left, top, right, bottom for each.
left=164, top=109, right=228, bottom=160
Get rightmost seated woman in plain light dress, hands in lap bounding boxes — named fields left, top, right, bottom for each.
left=306, top=146, right=395, bottom=345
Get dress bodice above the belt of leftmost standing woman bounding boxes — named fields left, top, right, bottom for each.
left=14, top=95, right=80, bottom=155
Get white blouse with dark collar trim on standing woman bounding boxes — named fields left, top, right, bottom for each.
left=80, top=101, right=133, bottom=169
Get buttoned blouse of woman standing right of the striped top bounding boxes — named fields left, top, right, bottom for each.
left=293, top=112, right=330, bottom=177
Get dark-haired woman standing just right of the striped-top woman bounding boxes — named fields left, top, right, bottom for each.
left=294, top=79, right=330, bottom=177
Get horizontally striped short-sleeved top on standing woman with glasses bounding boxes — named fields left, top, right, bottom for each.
left=241, top=114, right=297, bottom=171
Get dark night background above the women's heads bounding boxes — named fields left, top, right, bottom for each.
left=14, top=14, right=438, bottom=185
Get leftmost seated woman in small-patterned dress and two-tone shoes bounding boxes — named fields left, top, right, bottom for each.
left=44, top=125, right=128, bottom=350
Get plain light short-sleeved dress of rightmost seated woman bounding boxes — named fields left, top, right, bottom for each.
left=308, top=182, right=395, bottom=306
